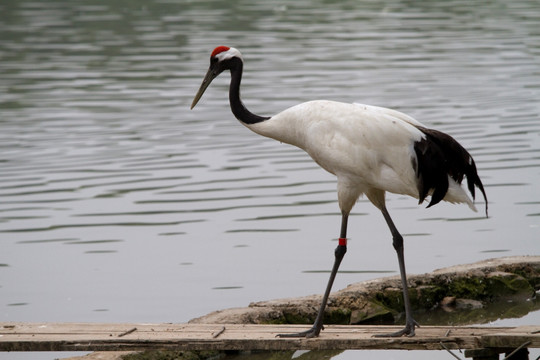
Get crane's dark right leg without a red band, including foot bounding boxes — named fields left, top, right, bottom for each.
left=375, top=206, right=420, bottom=337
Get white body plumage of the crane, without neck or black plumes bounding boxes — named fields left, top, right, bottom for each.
left=247, top=100, right=476, bottom=211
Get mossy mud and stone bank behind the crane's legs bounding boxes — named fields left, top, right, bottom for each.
left=190, top=256, right=540, bottom=325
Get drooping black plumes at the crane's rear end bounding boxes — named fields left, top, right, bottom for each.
left=414, top=126, right=488, bottom=216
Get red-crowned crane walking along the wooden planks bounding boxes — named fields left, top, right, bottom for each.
left=191, top=46, right=488, bottom=338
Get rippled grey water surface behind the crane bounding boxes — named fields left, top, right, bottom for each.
left=0, top=0, right=540, bottom=358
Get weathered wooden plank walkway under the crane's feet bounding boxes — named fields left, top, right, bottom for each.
left=0, top=323, right=540, bottom=351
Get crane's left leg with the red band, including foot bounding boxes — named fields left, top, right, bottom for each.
left=277, top=213, right=349, bottom=338
